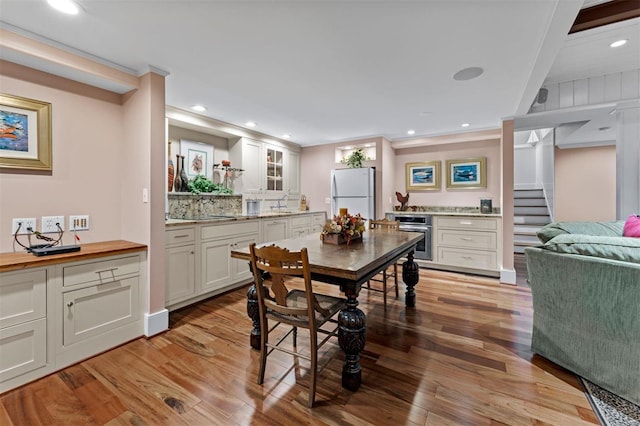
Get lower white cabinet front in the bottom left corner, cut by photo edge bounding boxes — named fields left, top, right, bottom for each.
left=0, top=318, right=47, bottom=382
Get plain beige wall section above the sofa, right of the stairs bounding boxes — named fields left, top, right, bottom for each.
left=554, top=146, right=616, bottom=221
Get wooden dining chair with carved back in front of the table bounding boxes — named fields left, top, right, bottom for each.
left=249, top=243, right=345, bottom=408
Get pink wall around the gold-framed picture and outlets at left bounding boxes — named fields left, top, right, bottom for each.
left=0, top=62, right=128, bottom=252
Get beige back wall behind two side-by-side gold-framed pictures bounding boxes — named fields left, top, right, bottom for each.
left=392, top=139, right=501, bottom=211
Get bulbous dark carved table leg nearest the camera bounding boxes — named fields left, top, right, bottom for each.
left=338, top=286, right=367, bottom=391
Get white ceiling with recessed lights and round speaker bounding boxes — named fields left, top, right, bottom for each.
left=0, top=0, right=640, bottom=146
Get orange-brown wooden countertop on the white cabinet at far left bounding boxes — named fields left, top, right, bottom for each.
left=0, top=240, right=147, bottom=272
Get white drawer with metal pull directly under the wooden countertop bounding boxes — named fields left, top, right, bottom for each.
left=62, top=255, right=140, bottom=287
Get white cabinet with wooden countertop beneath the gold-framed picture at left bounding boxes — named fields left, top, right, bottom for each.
left=0, top=242, right=146, bottom=392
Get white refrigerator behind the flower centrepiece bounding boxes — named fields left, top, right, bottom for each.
left=331, top=167, right=376, bottom=219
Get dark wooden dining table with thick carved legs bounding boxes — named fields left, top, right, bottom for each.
left=231, top=229, right=424, bottom=391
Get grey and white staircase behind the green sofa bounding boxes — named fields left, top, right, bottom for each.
left=513, top=189, right=551, bottom=253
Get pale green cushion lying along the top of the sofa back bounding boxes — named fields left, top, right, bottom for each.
left=542, top=233, right=640, bottom=263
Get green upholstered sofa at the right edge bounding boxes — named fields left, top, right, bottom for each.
left=525, top=221, right=640, bottom=405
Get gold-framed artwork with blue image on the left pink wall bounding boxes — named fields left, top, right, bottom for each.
left=0, top=94, right=52, bottom=171
